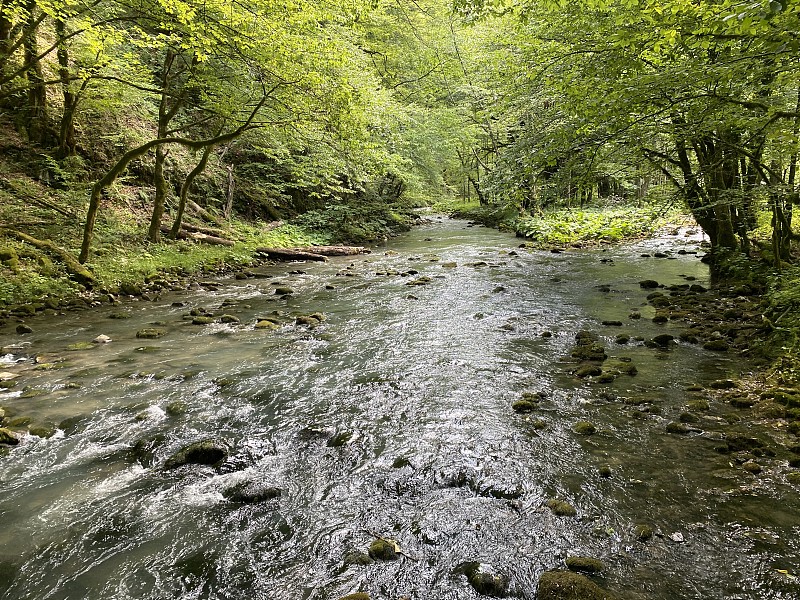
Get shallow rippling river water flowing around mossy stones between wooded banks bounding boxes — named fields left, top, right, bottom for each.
left=0, top=220, right=800, bottom=600
